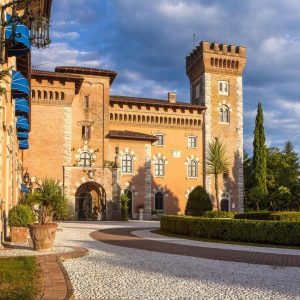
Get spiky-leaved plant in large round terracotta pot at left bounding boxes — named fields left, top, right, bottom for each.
left=28, top=178, right=67, bottom=251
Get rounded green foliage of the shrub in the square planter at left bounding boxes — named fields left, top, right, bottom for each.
left=8, top=204, right=35, bottom=227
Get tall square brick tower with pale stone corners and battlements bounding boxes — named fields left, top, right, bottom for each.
left=186, top=41, right=246, bottom=211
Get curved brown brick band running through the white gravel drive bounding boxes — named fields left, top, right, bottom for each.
left=90, top=228, right=300, bottom=267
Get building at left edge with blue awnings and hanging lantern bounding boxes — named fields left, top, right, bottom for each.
left=0, top=0, right=52, bottom=244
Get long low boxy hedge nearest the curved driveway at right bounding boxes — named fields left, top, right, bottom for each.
left=160, top=216, right=300, bottom=245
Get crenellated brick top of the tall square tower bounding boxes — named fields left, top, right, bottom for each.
left=186, top=41, right=246, bottom=73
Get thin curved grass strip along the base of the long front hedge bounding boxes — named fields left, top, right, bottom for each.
left=152, top=229, right=300, bottom=250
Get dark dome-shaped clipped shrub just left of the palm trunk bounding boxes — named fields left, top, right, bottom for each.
left=185, top=186, right=212, bottom=216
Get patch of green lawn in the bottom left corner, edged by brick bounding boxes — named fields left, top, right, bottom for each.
left=0, top=257, right=42, bottom=300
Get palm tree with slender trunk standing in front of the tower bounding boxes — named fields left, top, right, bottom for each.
left=206, top=139, right=229, bottom=213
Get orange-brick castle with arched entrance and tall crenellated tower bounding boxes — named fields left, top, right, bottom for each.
left=24, top=41, right=246, bottom=220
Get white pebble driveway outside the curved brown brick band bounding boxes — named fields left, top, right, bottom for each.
left=57, top=222, right=300, bottom=300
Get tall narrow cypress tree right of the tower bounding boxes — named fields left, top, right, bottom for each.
left=252, top=103, right=268, bottom=195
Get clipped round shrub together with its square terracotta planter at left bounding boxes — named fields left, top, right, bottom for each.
left=8, top=204, right=35, bottom=243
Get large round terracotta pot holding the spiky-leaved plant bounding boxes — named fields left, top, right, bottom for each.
left=28, top=224, right=57, bottom=251
